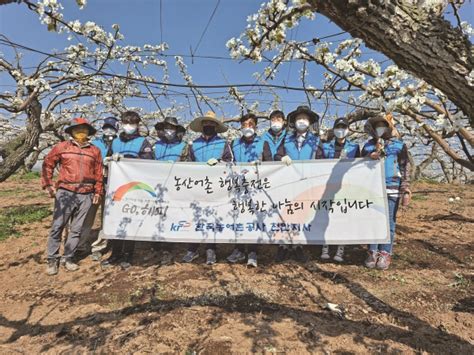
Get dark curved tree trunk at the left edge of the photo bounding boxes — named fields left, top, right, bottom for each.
left=0, top=98, right=42, bottom=182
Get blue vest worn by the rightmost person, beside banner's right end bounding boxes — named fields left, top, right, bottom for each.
left=362, top=138, right=405, bottom=188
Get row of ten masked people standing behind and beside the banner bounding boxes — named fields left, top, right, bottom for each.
left=42, top=106, right=411, bottom=275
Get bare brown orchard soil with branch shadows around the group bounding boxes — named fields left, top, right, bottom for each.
left=0, top=175, right=474, bottom=354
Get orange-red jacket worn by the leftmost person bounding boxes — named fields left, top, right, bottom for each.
left=41, top=140, right=103, bottom=195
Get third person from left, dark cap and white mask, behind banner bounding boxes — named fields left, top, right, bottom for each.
left=101, top=111, right=154, bottom=269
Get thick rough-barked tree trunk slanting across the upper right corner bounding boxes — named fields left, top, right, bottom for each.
left=309, top=0, right=474, bottom=125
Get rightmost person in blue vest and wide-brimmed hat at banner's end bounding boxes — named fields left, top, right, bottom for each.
left=362, top=114, right=411, bottom=270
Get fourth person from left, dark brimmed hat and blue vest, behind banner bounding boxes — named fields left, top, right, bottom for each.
left=154, top=117, right=188, bottom=265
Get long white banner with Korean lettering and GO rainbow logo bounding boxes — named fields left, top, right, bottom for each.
left=104, top=159, right=390, bottom=244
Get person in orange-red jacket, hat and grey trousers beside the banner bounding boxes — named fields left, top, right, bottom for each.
left=41, top=118, right=103, bottom=275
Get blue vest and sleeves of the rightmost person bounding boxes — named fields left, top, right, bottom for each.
left=362, top=138, right=410, bottom=190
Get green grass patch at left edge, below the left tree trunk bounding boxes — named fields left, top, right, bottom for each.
left=0, top=205, right=52, bottom=240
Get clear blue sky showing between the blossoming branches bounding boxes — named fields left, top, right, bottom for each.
left=0, top=0, right=474, bottom=128
